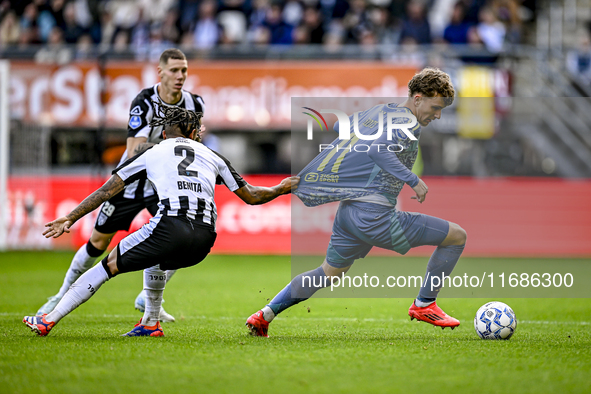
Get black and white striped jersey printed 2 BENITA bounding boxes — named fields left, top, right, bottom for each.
left=113, top=138, right=247, bottom=229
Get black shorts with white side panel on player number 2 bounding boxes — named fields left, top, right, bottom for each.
left=117, top=213, right=217, bottom=272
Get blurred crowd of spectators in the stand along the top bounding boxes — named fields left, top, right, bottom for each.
left=0, top=0, right=536, bottom=59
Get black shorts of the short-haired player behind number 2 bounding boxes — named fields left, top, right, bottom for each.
left=94, top=190, right=158, bottom=234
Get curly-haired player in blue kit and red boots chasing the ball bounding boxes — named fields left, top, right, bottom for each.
left=246, top=68, right=466, bottom=337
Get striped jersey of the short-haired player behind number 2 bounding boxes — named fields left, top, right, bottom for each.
left=119, top=83, right=205, bottom=199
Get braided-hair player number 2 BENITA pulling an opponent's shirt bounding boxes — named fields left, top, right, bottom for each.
left=23, top=106, right=299, bottom=336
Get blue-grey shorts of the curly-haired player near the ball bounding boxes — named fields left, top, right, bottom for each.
left=326, top=201, right=449, bottom=268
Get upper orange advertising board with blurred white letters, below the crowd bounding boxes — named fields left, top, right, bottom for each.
left=10, top=61, right=417, bottom=129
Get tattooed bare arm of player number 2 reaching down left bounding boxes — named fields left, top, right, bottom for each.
left=43, top=174, right=125, bottom=238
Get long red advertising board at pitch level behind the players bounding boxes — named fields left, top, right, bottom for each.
left=7, top=175, right=591, bottom=257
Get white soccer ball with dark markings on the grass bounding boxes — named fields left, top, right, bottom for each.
left=474, top=301, right=517, bottom=339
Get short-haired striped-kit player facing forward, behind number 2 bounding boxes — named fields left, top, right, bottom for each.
left=37, top=48, right=205, bottom=322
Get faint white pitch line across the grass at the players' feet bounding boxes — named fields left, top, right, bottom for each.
left=0, top=312, right=591, bottom=326
